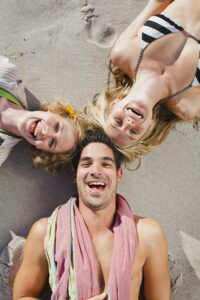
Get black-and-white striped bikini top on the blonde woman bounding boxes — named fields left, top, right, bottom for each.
left=135, top=14, right=200, bottom=98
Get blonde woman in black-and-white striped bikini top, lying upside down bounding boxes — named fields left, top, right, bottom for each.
left=87, top=0, right=200, bottom=159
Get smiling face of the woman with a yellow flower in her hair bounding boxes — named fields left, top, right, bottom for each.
left=18, top=111, right=78, bottom=153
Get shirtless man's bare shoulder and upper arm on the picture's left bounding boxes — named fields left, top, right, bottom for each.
left=13, top=218, right=48, bottom=300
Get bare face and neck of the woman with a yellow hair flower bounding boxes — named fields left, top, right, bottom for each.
left=0, top=97, right=78, bottom=153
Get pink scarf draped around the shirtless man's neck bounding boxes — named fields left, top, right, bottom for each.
left=51, top=195, right=136, bottom=300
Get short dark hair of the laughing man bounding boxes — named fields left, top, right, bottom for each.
left=72, top=129, right=124, bottom=173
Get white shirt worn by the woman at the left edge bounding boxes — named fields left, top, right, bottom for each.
left=0, top=55, right=28, bottom=166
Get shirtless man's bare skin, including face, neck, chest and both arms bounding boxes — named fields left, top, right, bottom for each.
left=13, top=143, right=170, bottom=300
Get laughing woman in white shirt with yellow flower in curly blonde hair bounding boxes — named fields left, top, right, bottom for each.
left=0, top=56, right=78, bottom=169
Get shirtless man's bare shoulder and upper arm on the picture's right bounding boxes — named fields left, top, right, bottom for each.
left=134, top=216, right=170, bottom=300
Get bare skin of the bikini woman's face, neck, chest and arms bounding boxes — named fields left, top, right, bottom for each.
left=106, top=0, right=200, bottom=146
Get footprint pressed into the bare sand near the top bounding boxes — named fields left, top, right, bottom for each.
left=81, top=3, right=117, bottom=48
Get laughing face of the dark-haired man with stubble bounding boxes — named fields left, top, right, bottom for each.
left=76, top=142, right=122, bottom=210
